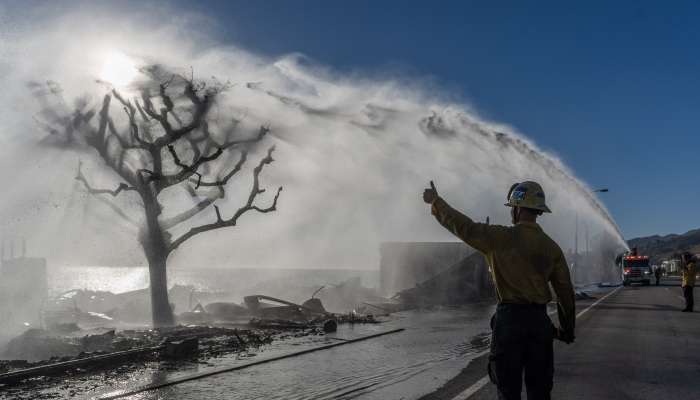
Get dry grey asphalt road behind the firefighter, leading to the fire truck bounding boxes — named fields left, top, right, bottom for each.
left=424, top=279, right=700, bottom=400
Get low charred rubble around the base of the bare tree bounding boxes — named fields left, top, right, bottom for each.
left=0, top=293, right=379, bottom=384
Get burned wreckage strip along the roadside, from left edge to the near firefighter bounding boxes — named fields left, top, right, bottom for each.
left=0, top=242, right=494, bottom=389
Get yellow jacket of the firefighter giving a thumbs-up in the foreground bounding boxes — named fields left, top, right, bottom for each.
left=432, top=198, right=575, bottom=332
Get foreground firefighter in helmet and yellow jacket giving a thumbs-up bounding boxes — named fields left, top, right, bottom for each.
left=423, top=181, right=575, bottom=400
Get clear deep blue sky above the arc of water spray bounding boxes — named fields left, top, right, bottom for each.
left=171, top=0, right=700, bottom=238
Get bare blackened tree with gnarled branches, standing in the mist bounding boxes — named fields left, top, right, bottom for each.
left=32, top=66, right=282, bottom=327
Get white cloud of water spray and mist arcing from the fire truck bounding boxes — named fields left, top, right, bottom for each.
left=0, top=1, right=625, bottom=269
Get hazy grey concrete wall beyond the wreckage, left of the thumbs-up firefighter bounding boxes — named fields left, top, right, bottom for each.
left=379, top=242, right=474, bottom=296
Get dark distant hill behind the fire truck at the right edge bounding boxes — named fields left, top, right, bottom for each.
left=627, top=229, right=700, bottom=264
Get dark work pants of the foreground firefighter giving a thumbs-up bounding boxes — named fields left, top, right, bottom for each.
left=489, top=304, right=554, bottom=400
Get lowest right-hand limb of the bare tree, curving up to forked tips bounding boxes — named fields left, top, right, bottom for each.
left=169, top=146, right=282, bottom=251
